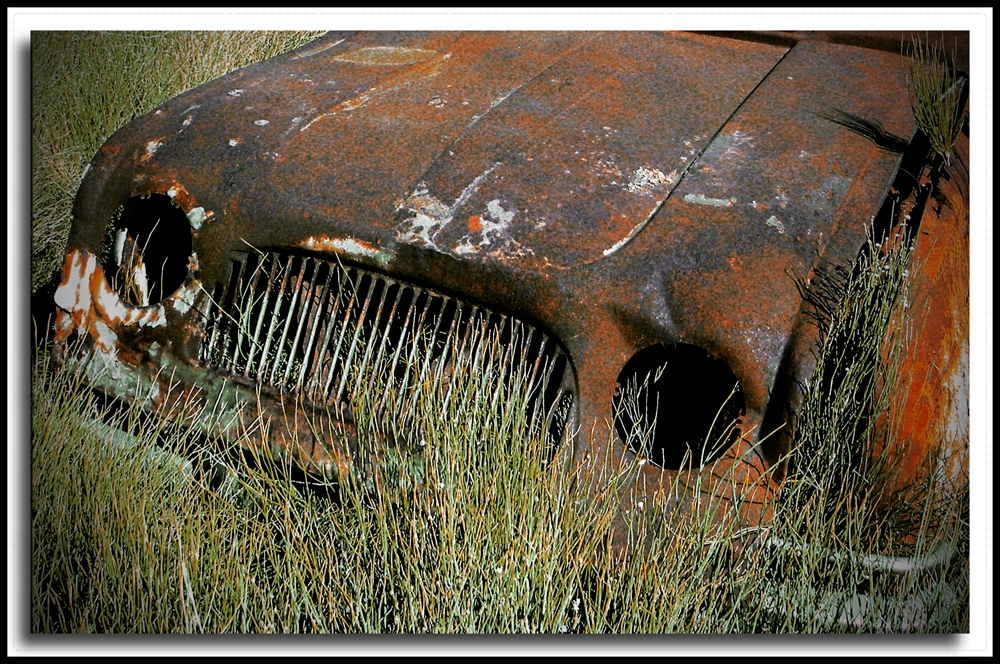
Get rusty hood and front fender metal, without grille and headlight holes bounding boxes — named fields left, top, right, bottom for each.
left=48, top=32, right=960, bottom=544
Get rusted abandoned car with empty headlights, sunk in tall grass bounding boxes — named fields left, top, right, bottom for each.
left=48, top=32, right=967, bottom=540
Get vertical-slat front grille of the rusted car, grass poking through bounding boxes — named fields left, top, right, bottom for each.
left=200, top=252, right=573, bottom=438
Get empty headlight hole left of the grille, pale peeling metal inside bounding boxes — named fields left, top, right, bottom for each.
left=102, top=194, right=192, bottom=307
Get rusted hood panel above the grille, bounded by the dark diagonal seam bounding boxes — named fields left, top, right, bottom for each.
left=68, top=32, right=787, bottom=269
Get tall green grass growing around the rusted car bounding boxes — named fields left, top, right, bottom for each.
left=30, top=35, right=969, bottom=633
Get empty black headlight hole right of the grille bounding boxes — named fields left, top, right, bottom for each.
left=613, top=344, right=746, bottom=470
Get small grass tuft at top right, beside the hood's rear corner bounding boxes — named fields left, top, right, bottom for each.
left=903, top=35, right=965, bottom=165
